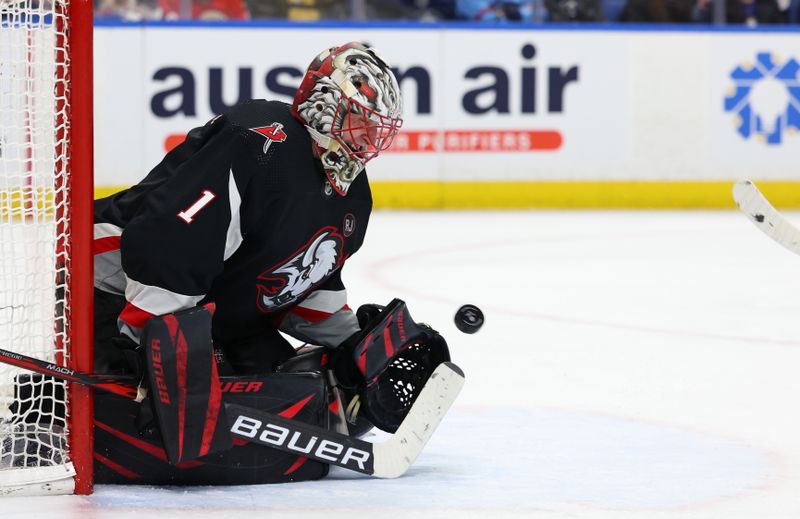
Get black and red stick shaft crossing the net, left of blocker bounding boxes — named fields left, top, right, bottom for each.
left=0, top=349, right=144, bottom=402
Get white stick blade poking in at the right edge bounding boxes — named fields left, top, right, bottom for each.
left=733, top=180, right=800, bottom=254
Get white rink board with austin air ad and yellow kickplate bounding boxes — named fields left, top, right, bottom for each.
left=90, top=23, right=800, bottom=208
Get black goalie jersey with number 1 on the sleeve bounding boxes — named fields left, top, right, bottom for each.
left=94, top=101, right=372, bottom=358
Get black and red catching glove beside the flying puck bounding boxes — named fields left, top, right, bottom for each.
left=333, top=299, right=450, bottom=432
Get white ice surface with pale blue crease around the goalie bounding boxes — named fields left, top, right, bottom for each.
left=6, top=211, right=800, bottom=519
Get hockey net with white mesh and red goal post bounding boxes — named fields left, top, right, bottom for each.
left=0, top=0, right=92, bottom=495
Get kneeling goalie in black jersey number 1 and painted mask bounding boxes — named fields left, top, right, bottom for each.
left=32, top=42, right=450, bottom=485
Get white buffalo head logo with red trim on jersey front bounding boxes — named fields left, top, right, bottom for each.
left=256, top=227, right=344, bottom=312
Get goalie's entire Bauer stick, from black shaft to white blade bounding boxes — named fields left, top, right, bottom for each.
left=0, top=349, right=464, bottom=478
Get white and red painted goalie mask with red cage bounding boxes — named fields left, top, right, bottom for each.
left=292, top=42, right=403, bottom=196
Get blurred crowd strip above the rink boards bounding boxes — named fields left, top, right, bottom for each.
left=95, top=0, right=800, bottom=26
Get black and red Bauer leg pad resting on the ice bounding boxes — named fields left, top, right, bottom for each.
left=94, top=372, right=333, bottom=485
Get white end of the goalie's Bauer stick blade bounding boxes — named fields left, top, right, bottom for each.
left=372, top=362, right=464, bottom=478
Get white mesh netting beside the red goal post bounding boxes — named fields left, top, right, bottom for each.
left=0, top=0, right=69, bottom=486
